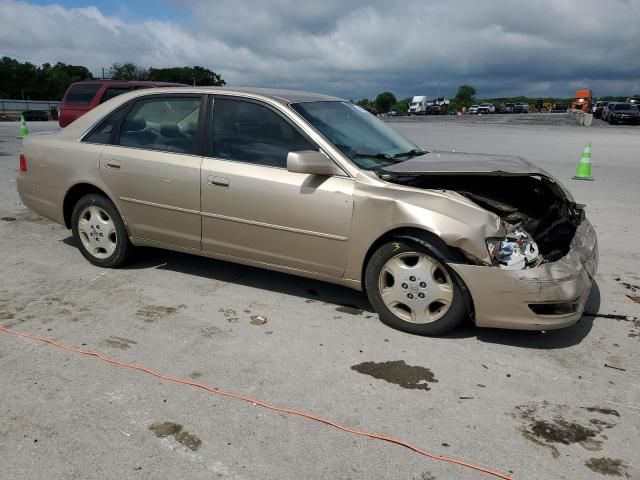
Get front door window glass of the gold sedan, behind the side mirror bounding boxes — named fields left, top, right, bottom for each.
left=211, top=98, right=317, bottom=168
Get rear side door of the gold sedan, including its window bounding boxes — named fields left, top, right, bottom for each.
left=100, top=94, right=204, bottom=250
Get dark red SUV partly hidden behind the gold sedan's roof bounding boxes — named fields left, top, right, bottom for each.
left=58, top=80, right=189, bottom=127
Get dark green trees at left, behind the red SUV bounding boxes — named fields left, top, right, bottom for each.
left=0, top=57, right=225, bottom=100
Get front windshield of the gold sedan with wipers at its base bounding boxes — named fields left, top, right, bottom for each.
left=291, top=102, right=425, bottom=170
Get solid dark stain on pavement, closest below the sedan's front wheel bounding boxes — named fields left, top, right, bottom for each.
left=351, top=360, right=438, bottom=390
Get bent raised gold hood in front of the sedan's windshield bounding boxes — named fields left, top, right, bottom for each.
left=383, top=151, right=551, bottom=177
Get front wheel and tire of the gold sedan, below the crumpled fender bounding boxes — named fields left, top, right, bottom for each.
left=365, top=240, right=468, bottom=336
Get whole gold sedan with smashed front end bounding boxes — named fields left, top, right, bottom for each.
left=17, top=87, right=598, bottom=335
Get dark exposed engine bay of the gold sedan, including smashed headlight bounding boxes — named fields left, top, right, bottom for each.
left=385, top=173, right=584, bottom=270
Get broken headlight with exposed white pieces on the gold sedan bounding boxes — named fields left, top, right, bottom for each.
left=487, top=228, right=542, bottom=270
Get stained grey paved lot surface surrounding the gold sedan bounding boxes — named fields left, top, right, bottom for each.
left=0, top=114, right=640, bottom=480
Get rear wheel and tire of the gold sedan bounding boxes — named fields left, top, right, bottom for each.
left=71, top=194, right=133, bottom=268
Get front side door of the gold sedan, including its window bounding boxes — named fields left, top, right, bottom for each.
left=201, top=97, right=354, bottom=277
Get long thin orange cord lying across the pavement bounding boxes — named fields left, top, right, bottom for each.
left=0, top=327, right=513, bottom=480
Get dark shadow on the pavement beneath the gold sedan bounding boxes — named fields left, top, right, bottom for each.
left=62, top=236, right=600, bottom=349
